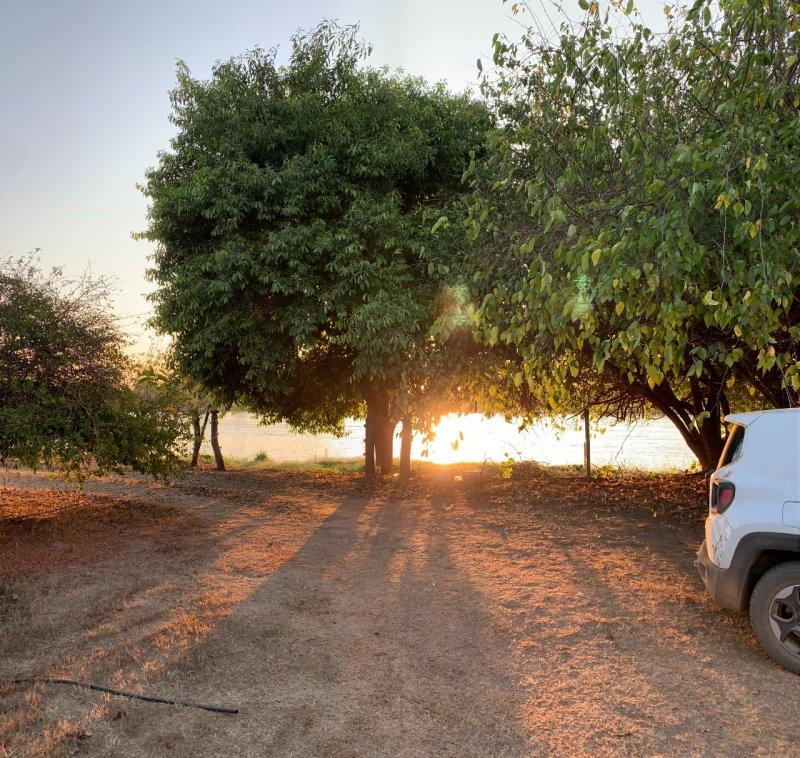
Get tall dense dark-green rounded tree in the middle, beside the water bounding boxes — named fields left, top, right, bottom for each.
left=143, top=23, right=488, bottom=473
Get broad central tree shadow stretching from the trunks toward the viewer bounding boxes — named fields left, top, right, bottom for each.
left=111, top=486, right=533, bottom=756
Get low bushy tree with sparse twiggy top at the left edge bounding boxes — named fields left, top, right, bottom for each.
left=0, top=257, right=186, bottom=481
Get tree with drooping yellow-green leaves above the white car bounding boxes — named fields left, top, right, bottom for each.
left=467, top=0, right=800, bottom=468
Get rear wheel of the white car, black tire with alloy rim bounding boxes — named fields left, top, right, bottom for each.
left=750, top=561, right=800, bottom=674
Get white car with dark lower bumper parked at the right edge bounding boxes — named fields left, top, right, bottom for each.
left=697, top=408, right=800, bottom=674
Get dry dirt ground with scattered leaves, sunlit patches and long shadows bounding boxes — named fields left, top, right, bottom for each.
left=0, top=470, right=800, bottom=758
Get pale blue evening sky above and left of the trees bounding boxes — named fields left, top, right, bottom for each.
left=0, top=0, right=668, bottom=352
